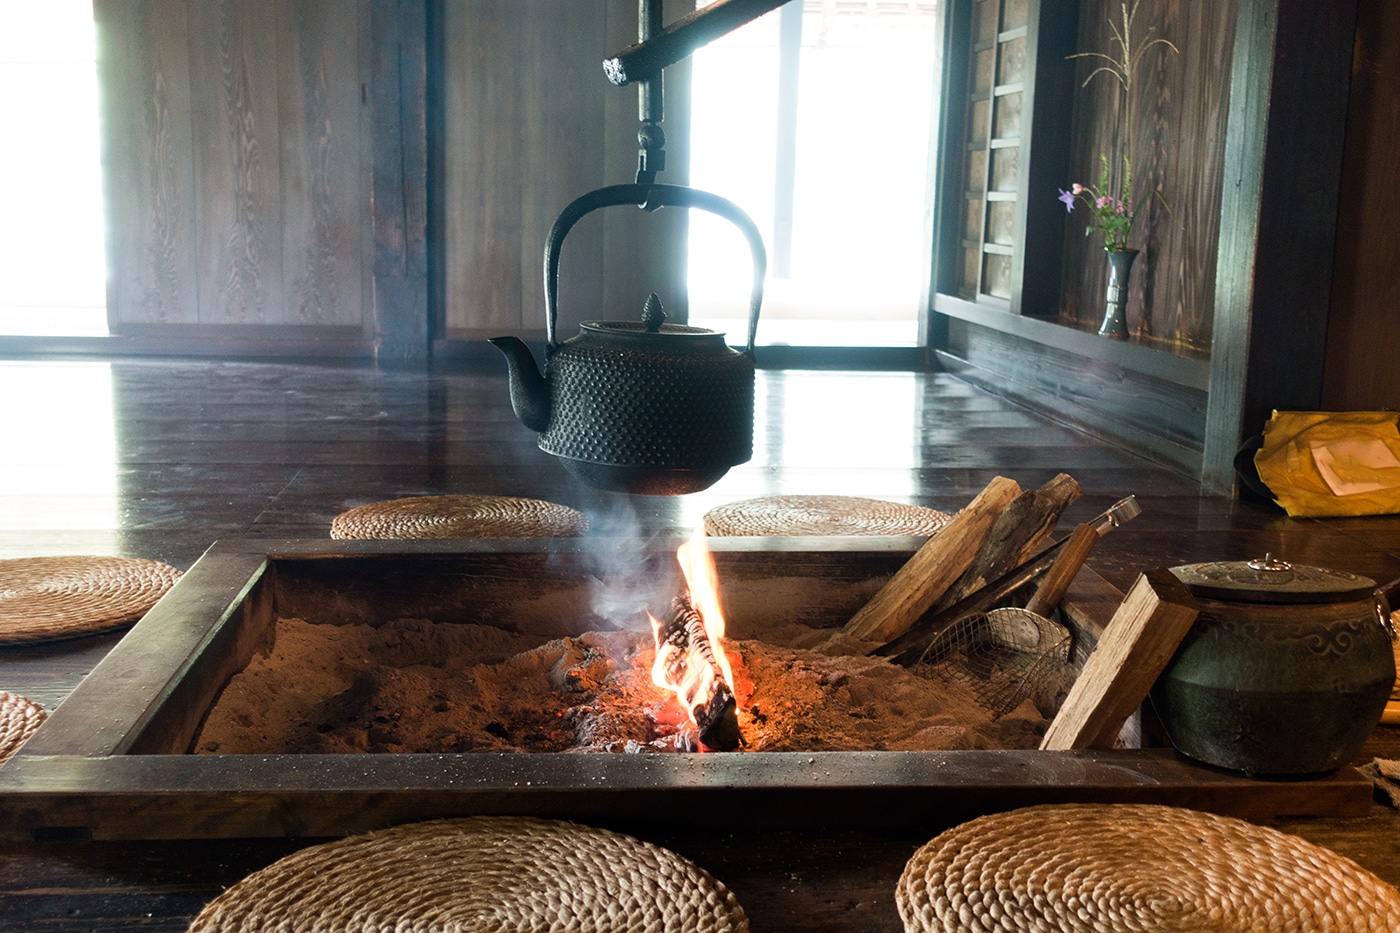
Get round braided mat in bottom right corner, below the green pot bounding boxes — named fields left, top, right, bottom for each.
left=895, top=804, right=1400, bottom=933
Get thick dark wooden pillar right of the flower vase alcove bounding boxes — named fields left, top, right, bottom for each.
left=1201, top=0, right=1357, bottom=490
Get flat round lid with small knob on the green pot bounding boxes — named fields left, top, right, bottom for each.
left=1172, top=553, right=1376, bottom=602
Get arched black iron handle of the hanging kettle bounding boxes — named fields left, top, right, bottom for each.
left=545, top=185, right=769, bottom=357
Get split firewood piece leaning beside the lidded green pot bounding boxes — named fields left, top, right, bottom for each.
left=1040, top=569, right=1200, bottom=751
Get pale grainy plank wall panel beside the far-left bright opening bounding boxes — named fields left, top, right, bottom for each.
left=94, top=0, right=371, bottom=335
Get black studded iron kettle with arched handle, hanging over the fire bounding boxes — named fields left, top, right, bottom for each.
left=490, top=185, right=767, bottom=496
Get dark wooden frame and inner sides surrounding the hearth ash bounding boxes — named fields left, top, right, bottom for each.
left=0, top=537, right=1371, bottom=841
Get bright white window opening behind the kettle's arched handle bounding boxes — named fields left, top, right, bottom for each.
left=689, top=0, right=939, bottom=346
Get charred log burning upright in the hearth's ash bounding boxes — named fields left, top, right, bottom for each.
left=651, top=595, right=741, bottom=751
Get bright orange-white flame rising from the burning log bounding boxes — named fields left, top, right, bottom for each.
left=647, top=530, right=734, bottom=719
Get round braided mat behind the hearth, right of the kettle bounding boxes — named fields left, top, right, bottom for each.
left=704, top=496, right=952, bottom=538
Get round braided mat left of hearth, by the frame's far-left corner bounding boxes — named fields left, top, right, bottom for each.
left=0, top=558, right=181, bottom=644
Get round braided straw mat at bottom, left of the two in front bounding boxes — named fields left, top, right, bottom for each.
left=189, top=817, right=749, bottom=933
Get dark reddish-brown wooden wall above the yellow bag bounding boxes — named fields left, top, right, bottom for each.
left=1322, top=0, right=1400, bottom=410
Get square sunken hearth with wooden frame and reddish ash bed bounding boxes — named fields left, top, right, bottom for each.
left=0, top=529, right=1371, bottom=839
